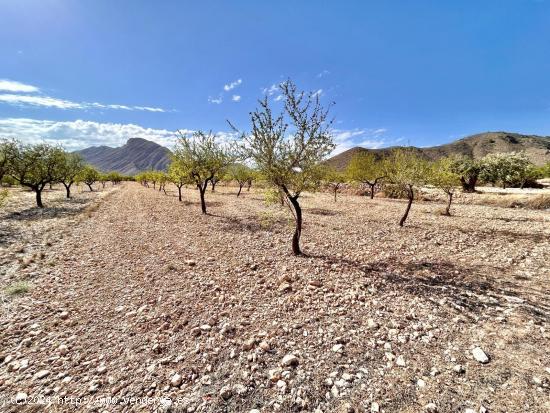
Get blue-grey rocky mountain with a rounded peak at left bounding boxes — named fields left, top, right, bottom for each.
left=77, top=138, right=170, bottom=175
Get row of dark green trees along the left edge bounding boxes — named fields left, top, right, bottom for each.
left=0, top=139, right=128, bottom=208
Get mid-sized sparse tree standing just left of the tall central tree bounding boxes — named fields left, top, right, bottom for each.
left=174, top=130, right=235, bottom=214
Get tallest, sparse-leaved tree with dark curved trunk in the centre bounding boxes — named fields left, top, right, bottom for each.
left=234, top=80, right=335, bottom=255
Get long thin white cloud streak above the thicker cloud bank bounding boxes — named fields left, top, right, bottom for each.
left=0, top=94, right=168, bottom=112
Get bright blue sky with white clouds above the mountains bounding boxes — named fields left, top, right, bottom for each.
left=0, top=0, right=550, bottom=151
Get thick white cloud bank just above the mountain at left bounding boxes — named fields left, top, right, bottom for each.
left=0, top=118, right=183, bottom=150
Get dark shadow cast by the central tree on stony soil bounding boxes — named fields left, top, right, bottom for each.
left=310, top=255, right=550, bottom=322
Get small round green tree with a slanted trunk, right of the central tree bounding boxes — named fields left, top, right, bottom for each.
left=384, top=149, right=430, bottom=227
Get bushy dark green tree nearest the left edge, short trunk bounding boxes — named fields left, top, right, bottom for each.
left=8, top=143, right=64, bottom=208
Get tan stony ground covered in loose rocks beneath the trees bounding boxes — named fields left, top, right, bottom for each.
left=0, top=183, right=550, bottom=413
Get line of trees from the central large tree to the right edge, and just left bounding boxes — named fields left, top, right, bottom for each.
left=136, top=80, right=550, bottom=255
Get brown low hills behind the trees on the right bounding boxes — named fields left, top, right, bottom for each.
left=326, top=132, right=550, bottom=170
